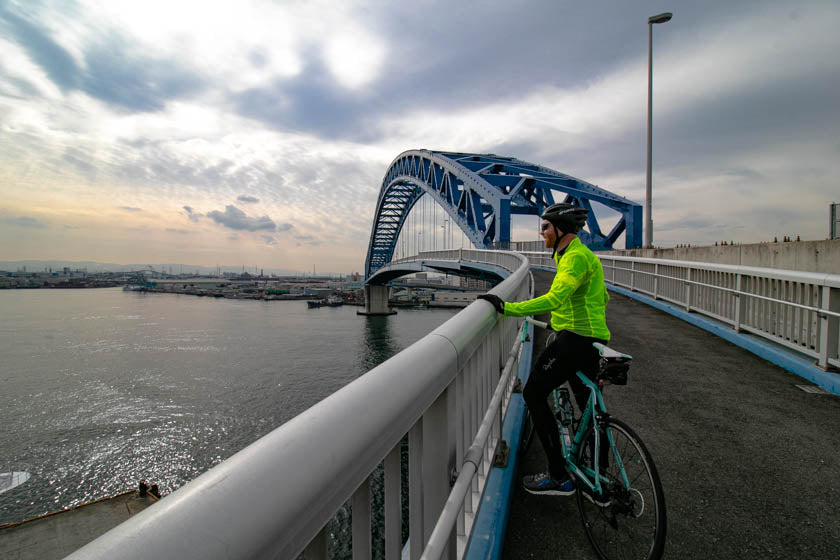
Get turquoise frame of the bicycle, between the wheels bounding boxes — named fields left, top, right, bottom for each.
left=553, top=371, right=630, bottom=494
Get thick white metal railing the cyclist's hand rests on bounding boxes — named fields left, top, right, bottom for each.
left=68, top=250, right=533, bottom=560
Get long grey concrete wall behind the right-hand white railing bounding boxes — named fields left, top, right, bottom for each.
left=599, top=239, right=840, bottom=274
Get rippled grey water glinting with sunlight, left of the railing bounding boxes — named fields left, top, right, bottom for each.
left=0, top=289, right=454, bottom=524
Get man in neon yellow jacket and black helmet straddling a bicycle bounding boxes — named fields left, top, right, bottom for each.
left=479, top=203, right=610, bottom=496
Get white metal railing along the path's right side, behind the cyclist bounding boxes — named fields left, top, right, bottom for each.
left=523, top=253, right=840, bottom=369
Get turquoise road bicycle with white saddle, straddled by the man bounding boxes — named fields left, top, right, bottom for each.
left=526, top=317, right=666, bottom=560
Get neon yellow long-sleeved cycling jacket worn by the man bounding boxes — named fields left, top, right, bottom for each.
left=498, top=237, right=610, bottom=341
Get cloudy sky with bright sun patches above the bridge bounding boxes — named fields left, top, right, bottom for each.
left=0, top=0, right=840, bottom=272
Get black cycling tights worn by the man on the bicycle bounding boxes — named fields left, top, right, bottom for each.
left=522, top=331, right=606, bottom=480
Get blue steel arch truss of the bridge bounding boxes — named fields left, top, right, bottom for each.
left=365, top=150, right=642, bottom=278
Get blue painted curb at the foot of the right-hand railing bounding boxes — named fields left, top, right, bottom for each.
left=607, top=284, right=840, bottom=395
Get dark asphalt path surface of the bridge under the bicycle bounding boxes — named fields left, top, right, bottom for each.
left=503, top=272, right=840, bottom=559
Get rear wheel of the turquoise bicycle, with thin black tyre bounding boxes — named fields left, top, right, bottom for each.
left=576, top=418, right=666, bottom=560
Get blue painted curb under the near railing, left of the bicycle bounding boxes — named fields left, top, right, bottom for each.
left=464, top=327, right=534, bottom=560
